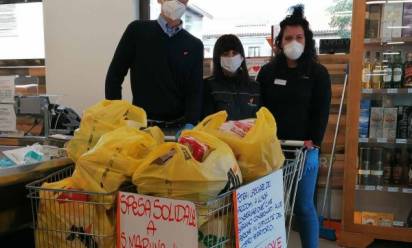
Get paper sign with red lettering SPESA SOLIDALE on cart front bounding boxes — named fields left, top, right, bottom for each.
left=117, top=192, right=198, bottom=248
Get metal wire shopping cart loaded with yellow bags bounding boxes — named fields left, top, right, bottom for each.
left=27, top=141, right=306, bottom=248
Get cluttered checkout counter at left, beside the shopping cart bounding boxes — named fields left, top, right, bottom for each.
left=0, top=92, right=80, bottom=247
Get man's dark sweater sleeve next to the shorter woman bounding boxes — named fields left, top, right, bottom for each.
left=184, top=41, right=203, bottom=125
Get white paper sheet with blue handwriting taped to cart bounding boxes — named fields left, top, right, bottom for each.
left=233, top=170, right=286, bottom=248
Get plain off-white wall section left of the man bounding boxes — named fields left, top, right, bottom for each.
left=43, top=0, right=139, bottom=113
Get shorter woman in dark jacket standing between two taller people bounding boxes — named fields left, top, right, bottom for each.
left=203, top=34, right=260, bottom=120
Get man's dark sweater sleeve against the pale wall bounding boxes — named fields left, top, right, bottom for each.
left=105, top=23, right=136, bottom=100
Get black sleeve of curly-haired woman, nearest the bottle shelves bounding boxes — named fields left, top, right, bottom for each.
left=309, top=65, right=332, bottom=146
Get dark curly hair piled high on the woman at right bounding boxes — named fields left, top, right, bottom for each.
left=275, top=4, right=317, bottom=65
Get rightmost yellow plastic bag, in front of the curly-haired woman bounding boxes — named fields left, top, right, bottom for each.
left=194, top=107, right=285, bottom=182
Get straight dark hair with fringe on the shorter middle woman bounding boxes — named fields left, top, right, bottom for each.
left=213, top=34, right=249, bottom=81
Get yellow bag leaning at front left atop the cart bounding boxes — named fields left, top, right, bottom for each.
left=72, top=127, right=162, bottom=204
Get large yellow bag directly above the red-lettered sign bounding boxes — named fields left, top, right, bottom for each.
left=133, top=131, right=242, bottom=202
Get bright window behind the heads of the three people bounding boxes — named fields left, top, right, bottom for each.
left=150, top=0, right=352, bottom=58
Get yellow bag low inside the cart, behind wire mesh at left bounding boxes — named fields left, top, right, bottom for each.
left=35, top=178, right=115, bottom=248
